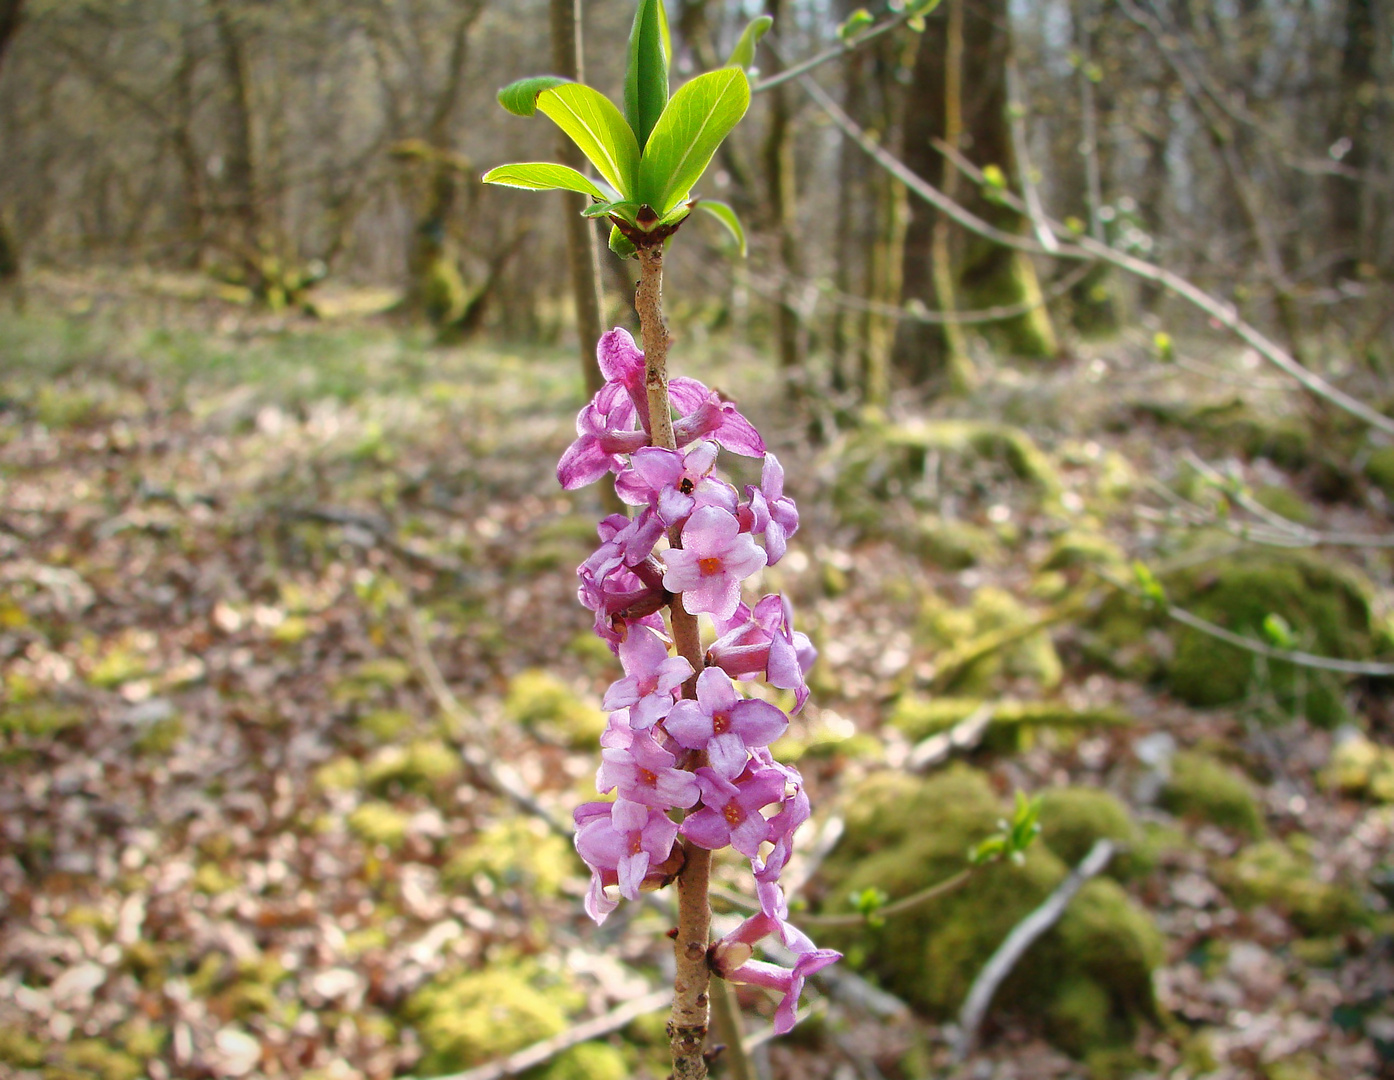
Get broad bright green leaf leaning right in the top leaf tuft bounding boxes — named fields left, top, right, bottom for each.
left=636, top=67, right=750, bottom=217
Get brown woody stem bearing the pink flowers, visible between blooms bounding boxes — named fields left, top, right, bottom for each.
left=634, top=244, right=711, bottom=1080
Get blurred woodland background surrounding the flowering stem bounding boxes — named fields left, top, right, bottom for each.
left=0, top=0, right=1394, bottom=1080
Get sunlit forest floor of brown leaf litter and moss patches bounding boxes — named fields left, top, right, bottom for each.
left=0, top=277, right=1394, bottom=1080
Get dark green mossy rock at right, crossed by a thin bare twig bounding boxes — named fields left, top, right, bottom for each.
left=1164, top=550, right=1374, bottom=726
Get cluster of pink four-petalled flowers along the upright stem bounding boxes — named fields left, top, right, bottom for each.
left=556, top=329, right=839, bottom=1033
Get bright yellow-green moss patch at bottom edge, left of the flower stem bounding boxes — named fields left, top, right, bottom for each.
left=406, top=966, right=580, bottom=1076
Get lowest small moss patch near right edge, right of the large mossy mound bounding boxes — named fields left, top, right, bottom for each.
left=1217, top=840, right=1362, bottom=935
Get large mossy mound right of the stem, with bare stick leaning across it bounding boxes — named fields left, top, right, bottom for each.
left=820, top=766, right=1161, bottom=1054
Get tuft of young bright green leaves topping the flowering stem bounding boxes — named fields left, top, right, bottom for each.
left=484, top=0, right=771, bottom=256
